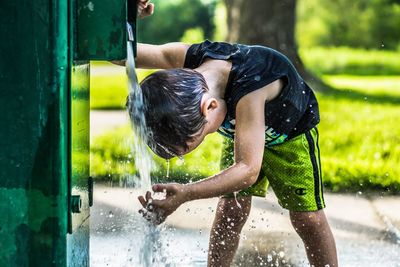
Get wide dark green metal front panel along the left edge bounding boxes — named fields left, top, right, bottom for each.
left=0, top=0, right=68, bottom=266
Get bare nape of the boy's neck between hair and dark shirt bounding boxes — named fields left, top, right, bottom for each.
left=195, top=59, right=232, bottom=99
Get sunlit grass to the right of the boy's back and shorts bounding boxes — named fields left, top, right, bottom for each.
left=318, top=76, right=400, bottom=191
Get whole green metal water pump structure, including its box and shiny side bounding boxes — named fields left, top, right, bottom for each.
left=0, top=0, right=136, bottom=266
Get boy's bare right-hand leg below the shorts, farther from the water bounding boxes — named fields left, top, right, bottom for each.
left=290, top=210, right=338, bottom=267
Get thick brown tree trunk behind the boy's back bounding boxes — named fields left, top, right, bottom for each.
left=224, top=0, right=325, bottom=89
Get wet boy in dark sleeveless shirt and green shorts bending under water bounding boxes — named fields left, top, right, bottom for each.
left=127, top=0, right=338, bottom=267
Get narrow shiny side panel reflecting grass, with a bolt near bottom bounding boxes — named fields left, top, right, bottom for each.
left=67, top=61, right=90, bottom=266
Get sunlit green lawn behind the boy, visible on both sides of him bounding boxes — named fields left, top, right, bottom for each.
left=91, top=75, right=400, bottom=192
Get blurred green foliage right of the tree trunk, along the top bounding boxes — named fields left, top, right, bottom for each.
left=297, top=0, right=400, bottom=50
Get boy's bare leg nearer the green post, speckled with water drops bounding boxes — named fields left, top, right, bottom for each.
left=208, top=196, right=251, bottom=267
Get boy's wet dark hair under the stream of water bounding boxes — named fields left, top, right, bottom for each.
left=127, top=69, right=208, bottom=159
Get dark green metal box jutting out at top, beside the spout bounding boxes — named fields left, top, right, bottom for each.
left=74, top=0, right=126, bottom=60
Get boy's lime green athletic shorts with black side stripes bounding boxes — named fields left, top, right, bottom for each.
left=221, top=128, right=325, bottom=214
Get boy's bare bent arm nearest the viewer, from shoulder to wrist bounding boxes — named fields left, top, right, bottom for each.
left=186, top=90, right=265, bottom=200
